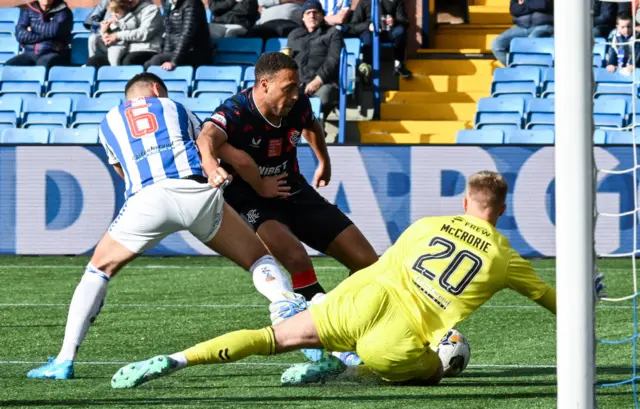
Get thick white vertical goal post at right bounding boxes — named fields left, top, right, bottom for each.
left=554, top=0, right=595, bottom=409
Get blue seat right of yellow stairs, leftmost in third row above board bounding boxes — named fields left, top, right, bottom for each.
left=491, top=66, right=540, bottom=97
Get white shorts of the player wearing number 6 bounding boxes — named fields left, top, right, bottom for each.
left=109, top=179, right=224, bottom=254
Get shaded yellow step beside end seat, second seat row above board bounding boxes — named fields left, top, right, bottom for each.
left=380, top=103, right=476, bottom=121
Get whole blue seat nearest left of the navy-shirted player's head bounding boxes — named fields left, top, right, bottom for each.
left=193, top=66, right=242, bottom=99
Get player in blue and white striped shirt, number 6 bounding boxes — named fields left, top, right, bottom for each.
left=27, top=73, right=304, bottom=379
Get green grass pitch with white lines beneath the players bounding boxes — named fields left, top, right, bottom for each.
left=0, top=257, right=634, bottom=409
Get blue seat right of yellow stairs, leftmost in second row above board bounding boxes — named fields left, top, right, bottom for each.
left=475, top=98, right=524, bottom=129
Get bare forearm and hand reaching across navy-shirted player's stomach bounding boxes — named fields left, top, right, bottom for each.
left=219, top=143, right=291, bottom=197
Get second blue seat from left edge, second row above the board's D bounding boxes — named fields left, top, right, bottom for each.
left=22, top=97, right=71, bottom=128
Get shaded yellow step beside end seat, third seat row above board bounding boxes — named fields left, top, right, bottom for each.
left=400, top=74, right=493, bottom=94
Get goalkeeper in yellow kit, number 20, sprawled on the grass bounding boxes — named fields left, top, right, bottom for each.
left=111, top=171, right=556, bottom=388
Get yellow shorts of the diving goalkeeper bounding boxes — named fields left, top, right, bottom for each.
left=309, top=267, right=440, bottom=382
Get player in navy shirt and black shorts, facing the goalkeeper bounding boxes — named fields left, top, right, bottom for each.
left=205, top=52, right=378, bottom=299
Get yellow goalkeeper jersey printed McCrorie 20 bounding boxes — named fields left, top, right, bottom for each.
left=375, top=215, right=556, bottom=346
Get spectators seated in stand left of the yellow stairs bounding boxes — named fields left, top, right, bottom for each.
left=6, top=0, right=411, bottom=118
